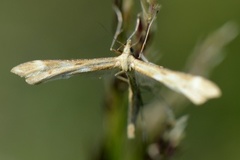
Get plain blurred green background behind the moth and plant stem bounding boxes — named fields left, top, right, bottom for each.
left=0, top=0, right=240, bottom=160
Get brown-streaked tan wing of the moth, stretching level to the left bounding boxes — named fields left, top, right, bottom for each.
left=11, top=58, right=118, bottom=84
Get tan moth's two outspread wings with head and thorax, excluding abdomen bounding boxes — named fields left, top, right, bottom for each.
left=11, top=40, right=221, bottom=105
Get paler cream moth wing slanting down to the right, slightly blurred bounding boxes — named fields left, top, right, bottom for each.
left=132, top=59, right=221, bottom=105
